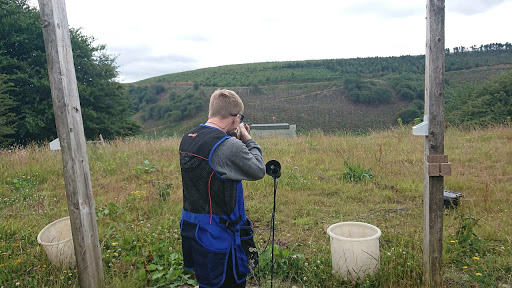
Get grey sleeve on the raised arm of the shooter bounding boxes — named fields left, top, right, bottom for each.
left=211, top=137, right=265, bottom=181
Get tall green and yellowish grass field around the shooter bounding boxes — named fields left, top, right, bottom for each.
left=0, top=127, right=512, bottom=287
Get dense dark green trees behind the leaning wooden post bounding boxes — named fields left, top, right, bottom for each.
left=0, top=0, right=141, bottom=146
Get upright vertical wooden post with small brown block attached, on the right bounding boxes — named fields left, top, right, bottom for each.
left=423, top=0, right=445, bottom=287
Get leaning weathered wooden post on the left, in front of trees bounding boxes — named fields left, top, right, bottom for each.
left=39, top=0, right=104, bottom=287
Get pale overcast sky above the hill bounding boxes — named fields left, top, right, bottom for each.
left=31, top=0, right=512, bottom=82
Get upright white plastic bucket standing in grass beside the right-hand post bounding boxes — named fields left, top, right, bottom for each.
left=327, top=222, right=382, bottom=281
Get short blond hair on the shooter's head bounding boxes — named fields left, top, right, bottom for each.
left=208, top=89, right=244, bottom=119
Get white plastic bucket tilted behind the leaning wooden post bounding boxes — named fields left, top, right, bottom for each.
left=37, top=217, right=76, bottom=267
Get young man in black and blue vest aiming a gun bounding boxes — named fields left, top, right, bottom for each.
left=179, top=90, right=265, bottom=288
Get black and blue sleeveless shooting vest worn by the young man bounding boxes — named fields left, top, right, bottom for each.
left=179, top=125, right=253, bottom=288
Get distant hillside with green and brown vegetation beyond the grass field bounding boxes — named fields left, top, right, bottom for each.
left=126, top=43, right=512, bottom=135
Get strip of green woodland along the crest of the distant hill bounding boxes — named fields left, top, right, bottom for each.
left=145, top=42, right=512, bottom=87
